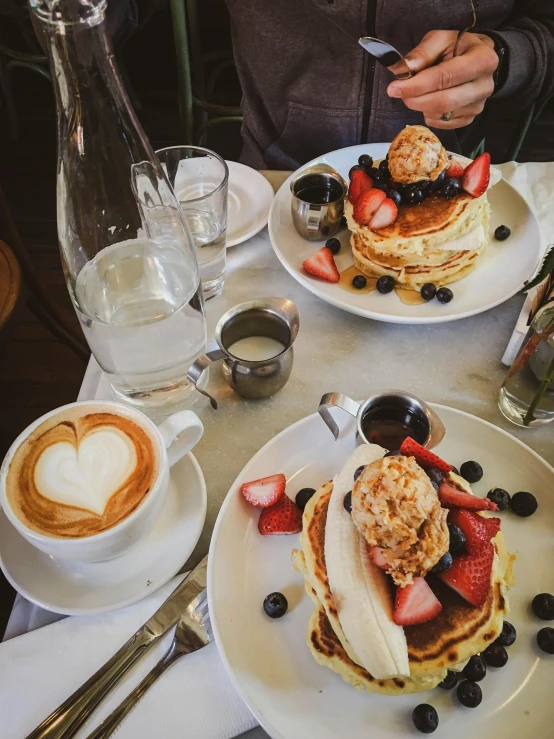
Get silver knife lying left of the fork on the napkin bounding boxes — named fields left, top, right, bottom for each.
left=27, top=556, right=208, bottom=739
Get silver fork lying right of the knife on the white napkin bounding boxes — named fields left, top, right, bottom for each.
left=87, top=590, right=213, bottom=739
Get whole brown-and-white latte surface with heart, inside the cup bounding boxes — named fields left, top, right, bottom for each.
left=6, top=406, right=159, bottom=538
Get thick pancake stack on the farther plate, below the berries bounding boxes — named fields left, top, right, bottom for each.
left=345, top=157, right=499, bottom=291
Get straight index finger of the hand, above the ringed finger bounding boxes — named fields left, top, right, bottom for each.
left=387, top=43, right=498, bottom=102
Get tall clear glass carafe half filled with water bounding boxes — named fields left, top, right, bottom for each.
left=31, top=0, right=206, bottom=415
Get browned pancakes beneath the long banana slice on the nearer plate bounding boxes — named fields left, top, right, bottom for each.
left=293, top=482, right=512, bottom=695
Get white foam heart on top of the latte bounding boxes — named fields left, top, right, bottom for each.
left=35, top=426, right=137, bottom=516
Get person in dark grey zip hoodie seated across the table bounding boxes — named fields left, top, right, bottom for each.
left=226, top=0, right=554, bottom=169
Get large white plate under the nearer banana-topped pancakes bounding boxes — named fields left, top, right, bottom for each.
left=208, top=405, right=554, bottom=739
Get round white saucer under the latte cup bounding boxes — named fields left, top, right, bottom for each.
left=0, top=454, right=207, bottom=616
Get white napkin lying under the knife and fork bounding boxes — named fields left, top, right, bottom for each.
left=0, top=576, right=257, bottom=739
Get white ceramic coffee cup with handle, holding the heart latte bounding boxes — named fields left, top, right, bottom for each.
left=0, top=400, right=204, bottom=562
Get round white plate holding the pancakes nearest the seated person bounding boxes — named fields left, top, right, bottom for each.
left=269, top=144, right=542, bottom=323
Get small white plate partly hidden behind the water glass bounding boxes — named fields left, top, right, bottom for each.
left=227, top=162, right=275, bottom=246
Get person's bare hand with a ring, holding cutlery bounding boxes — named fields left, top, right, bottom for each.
left=387, top=31, right=498, bottom=129
